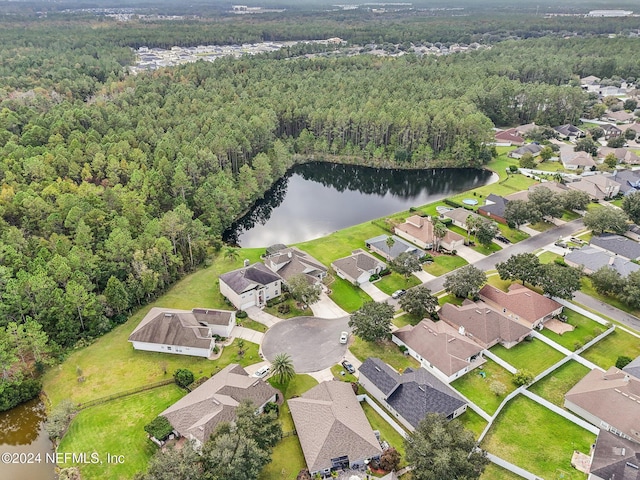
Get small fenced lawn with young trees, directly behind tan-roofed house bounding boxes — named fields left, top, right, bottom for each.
left=451, top=358, right=516, bottom=415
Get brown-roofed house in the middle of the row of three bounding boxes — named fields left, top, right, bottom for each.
left=438, top=300, right=531, bottom=349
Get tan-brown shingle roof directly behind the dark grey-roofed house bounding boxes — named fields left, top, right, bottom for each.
left=393, top=319, right=483, bottom=376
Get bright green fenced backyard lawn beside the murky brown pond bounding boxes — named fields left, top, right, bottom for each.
left=58, top=385, right=185, bottom=480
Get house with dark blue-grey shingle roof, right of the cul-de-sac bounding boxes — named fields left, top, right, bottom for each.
left=358, top=357, right=467, bottom=431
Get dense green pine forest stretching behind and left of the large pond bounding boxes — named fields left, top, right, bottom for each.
left=0, top=10, right=640, bottom=403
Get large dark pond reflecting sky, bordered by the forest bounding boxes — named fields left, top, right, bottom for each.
left=224, top=162, right=492, bottom=247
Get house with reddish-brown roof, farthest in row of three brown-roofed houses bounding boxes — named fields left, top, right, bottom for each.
left=479, top=283, right=562, bottom=328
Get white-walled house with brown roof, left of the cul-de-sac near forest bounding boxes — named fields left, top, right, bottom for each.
left=129, top=307, right=236, bottom=358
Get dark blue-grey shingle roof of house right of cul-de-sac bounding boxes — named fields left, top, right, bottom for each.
left=359, top=358, right=465, bottom=427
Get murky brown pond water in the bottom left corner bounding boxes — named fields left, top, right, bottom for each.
left=0, top=399, right=56, bottom=480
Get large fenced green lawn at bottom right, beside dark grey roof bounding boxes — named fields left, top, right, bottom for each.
left=482, top=395, right=596, bottom=480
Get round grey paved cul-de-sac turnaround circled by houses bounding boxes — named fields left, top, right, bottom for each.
left=262, top=317, right=350, bottom=373
